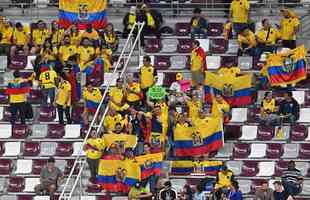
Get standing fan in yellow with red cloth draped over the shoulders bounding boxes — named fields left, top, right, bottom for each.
left=191, top=40, right=207, bottom=87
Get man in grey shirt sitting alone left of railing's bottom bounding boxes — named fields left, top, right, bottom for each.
left=34, top=157, right=64, bottom=196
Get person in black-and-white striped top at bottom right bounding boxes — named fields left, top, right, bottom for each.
left=282, top=160, right=303, bottom=196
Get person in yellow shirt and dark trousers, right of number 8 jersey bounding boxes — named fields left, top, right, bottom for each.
left=54, top=76, right=71, bottom=124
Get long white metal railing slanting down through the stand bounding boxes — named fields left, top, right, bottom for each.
left=59, top=23, right=144, bottom=200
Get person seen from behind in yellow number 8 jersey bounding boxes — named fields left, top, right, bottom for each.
left=39, top=69, right=57, bottom=105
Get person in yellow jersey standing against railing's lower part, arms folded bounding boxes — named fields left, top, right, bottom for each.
left=83, top=129, right=105, bottom=183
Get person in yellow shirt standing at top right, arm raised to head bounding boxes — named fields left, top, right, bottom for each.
left=280, top=9, right=300, bottom=49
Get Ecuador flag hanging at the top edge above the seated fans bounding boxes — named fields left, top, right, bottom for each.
left=59, top=0, right=107, bottom=29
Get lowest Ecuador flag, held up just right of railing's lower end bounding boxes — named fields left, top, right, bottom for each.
left=97, top=159, right=141, bottom=193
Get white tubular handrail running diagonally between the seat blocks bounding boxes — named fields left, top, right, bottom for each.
left=59, top=23, right=144, bottom=200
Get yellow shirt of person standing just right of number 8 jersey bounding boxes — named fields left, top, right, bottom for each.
left=56, top=81, right=71, bottom=106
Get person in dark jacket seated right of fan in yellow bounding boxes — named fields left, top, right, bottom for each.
left=279, top=91, right=300, bottom=123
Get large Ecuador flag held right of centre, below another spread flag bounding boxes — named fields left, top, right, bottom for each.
left=173, top=117, right=224, bottom=157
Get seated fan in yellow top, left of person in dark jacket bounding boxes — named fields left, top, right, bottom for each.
left=260, top=92, right=280, bottom=126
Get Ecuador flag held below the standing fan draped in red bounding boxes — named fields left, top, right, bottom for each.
left=204, top=71, right=253, bottom=106
